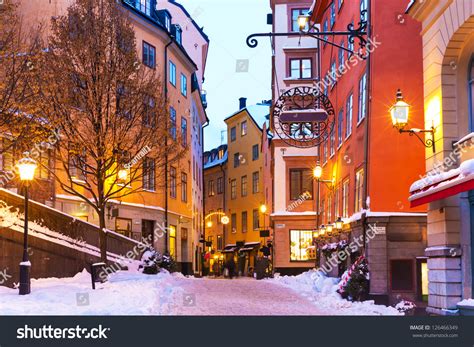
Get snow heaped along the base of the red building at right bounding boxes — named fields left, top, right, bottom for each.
left=268, top=270, right=403, bottom=316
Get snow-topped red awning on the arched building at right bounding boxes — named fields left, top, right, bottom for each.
left=409, top=173, right=474, bottom=207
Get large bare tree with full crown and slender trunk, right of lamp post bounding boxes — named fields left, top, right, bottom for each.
left=37, top=0, right=186, bottom=262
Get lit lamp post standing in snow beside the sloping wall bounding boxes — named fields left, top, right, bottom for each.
left=17, top=152, right=37, bottom=295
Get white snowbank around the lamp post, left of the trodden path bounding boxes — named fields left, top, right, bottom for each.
left=0, top=269, right=183, bottom=315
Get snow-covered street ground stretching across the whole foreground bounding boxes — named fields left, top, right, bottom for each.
left=0, top=270, right=398, bottom=316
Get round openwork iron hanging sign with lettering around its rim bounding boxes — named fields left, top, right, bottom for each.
left=272, top=87, right=335, bottom=148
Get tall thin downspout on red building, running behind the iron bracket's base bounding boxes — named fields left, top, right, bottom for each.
left=361, top=1, right=372, bottom=255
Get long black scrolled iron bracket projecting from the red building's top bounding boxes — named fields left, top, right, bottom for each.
left=247, top=10, right=367, bottom=59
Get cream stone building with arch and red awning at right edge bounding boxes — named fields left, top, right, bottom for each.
left=407, top=0, right=474, bottom=315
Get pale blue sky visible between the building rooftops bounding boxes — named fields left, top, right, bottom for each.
left=179, top=0, right=271, bottom=150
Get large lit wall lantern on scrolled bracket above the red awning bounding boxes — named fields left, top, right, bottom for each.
left=390, top=89, right=436, bottom=153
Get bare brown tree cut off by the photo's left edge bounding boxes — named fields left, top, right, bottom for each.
left=0, top=0, right=44, bottom=157
